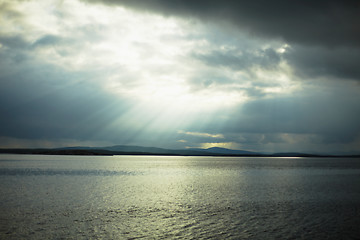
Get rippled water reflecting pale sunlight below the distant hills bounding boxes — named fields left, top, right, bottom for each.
left=0, top=155, right=360, bottom=239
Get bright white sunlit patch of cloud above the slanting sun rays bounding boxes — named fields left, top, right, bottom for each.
left=1, top=1, right=293, bottom=104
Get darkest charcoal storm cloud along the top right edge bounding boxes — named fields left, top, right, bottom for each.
left=83, top=0, right=360, bottom=46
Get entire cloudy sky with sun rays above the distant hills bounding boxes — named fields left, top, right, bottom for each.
left=0, top=0, right=360, bottom=153
